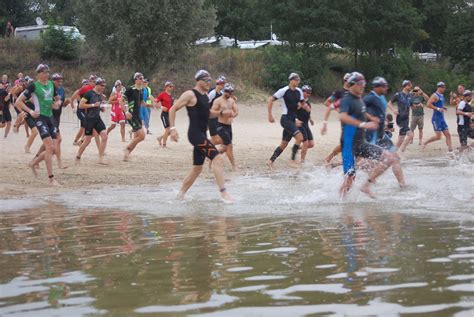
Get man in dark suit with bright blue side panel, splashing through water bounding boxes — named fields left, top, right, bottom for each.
left=339, top=72, right=398, bottom=198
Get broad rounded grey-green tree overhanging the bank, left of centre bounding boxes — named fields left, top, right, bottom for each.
left=77, top=0, right=215, bottom=69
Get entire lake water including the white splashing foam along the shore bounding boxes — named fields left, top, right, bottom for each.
left=0, top=159, right=474, bottom=317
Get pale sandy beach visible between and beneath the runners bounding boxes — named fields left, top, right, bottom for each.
left=0, top=101, right=459, bottom=198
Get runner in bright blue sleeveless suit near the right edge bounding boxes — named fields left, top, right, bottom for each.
left=423, top=81, right=453, bottom=156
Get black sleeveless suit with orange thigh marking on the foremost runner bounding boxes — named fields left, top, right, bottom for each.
left=186, top=89, right=219, bottom=166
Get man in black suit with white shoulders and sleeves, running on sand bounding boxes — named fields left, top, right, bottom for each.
left=267, top=73, right=305, bottom=168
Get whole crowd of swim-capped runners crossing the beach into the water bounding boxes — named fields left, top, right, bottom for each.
left=0, top=64, right=474, bottom=202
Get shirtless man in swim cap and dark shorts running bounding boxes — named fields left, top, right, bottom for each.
left=211, top=83, right=239, bottom=172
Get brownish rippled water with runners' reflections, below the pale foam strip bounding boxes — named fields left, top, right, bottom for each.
left=0, top=199, right=474, bottom=316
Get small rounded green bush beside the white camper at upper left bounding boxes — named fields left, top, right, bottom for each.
left=40, top=26, right=80, bottom=61
